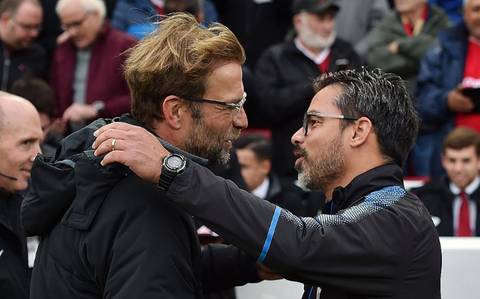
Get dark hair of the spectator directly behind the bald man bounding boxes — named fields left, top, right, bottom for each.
left=10, top=77, right=55, bottom=118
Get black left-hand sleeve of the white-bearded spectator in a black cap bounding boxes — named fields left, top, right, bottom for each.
left=253, top=46, right=320, bottom=123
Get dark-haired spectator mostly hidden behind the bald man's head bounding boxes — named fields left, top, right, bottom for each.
left=10, top=77, right=62, bottom=157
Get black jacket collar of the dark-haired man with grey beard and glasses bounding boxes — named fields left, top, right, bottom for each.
left=323, top=164, right=404, bottom=214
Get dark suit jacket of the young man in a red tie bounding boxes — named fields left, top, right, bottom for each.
left=412, top=174, right=480, bottom=236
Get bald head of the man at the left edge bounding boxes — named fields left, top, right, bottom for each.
left=0, top=92, right=42, bottom=193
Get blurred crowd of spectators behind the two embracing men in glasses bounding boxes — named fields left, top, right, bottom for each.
left=0, top=0, right=480, bottom=298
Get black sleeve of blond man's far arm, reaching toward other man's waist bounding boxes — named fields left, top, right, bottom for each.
left=202, top=244, right=261, bottom=294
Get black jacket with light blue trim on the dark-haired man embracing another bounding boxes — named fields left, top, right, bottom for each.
left=167, top=162, right=442, bottom=299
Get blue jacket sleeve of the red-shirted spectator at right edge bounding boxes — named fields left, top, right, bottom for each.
left=415, top=45, right=454, bottom=124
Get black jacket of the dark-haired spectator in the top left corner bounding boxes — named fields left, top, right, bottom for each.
left=0, top=41, right=48, bottom=91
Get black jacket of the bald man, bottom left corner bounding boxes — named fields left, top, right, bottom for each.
left=0, top=188, right=29, bottom=299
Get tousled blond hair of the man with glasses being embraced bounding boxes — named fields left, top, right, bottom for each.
left=125, top=13, right=245, bottom=128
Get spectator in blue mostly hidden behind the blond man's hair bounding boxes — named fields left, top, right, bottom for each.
left=112, top=0, right=219, bottom=39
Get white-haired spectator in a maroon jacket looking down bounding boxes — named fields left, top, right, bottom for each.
left=50, top=0, right=137, bottom=135
